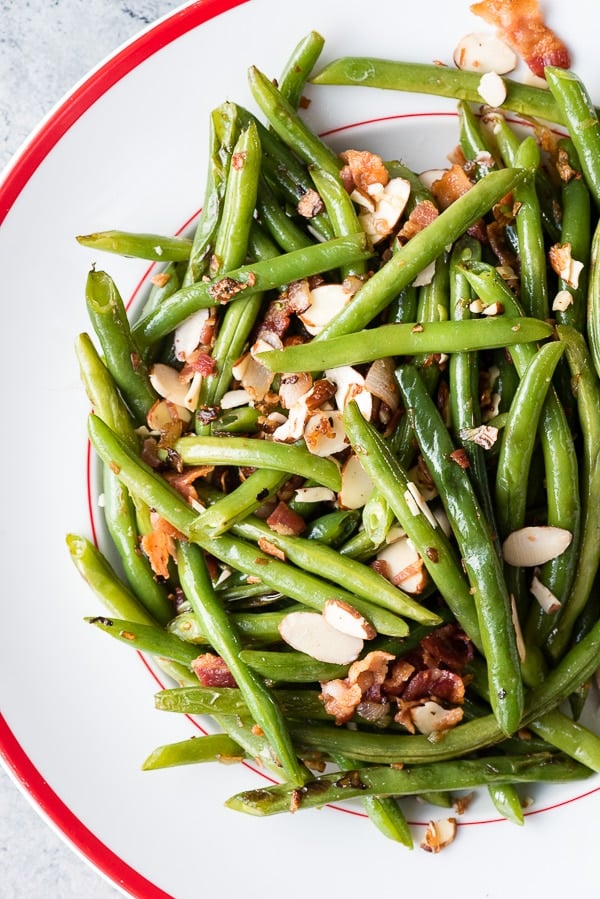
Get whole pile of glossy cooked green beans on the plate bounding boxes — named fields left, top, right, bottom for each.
left=67, top=32, right=600, bottom=847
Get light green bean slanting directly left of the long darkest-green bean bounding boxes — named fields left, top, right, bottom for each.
left=344, top=401, right=481, bottom=646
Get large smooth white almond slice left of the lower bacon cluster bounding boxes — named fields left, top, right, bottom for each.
left=279, top=611, right=364, bottom=665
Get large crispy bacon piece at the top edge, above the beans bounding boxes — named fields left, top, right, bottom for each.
left=471, top=0, right=571, bottom=78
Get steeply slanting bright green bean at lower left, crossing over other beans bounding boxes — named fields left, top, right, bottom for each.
left=177, top=542, right=307, bottom=785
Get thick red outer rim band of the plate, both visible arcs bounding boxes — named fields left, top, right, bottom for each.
left=0, top=0, right=248, bottom=899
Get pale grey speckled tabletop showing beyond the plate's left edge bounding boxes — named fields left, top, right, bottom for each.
left=0, top=0, right=182, bottom=899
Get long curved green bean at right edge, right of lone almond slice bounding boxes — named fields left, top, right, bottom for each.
left=548, top=325, right=600, bottom=660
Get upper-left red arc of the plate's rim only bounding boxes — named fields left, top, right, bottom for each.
left=0, top=0, right=248, bottom=225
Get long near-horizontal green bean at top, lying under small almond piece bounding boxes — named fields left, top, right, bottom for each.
left=311, top=56, right=564, bottom=124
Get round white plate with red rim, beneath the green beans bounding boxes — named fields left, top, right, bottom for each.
left=0, top=0, right=600, bottom=899
